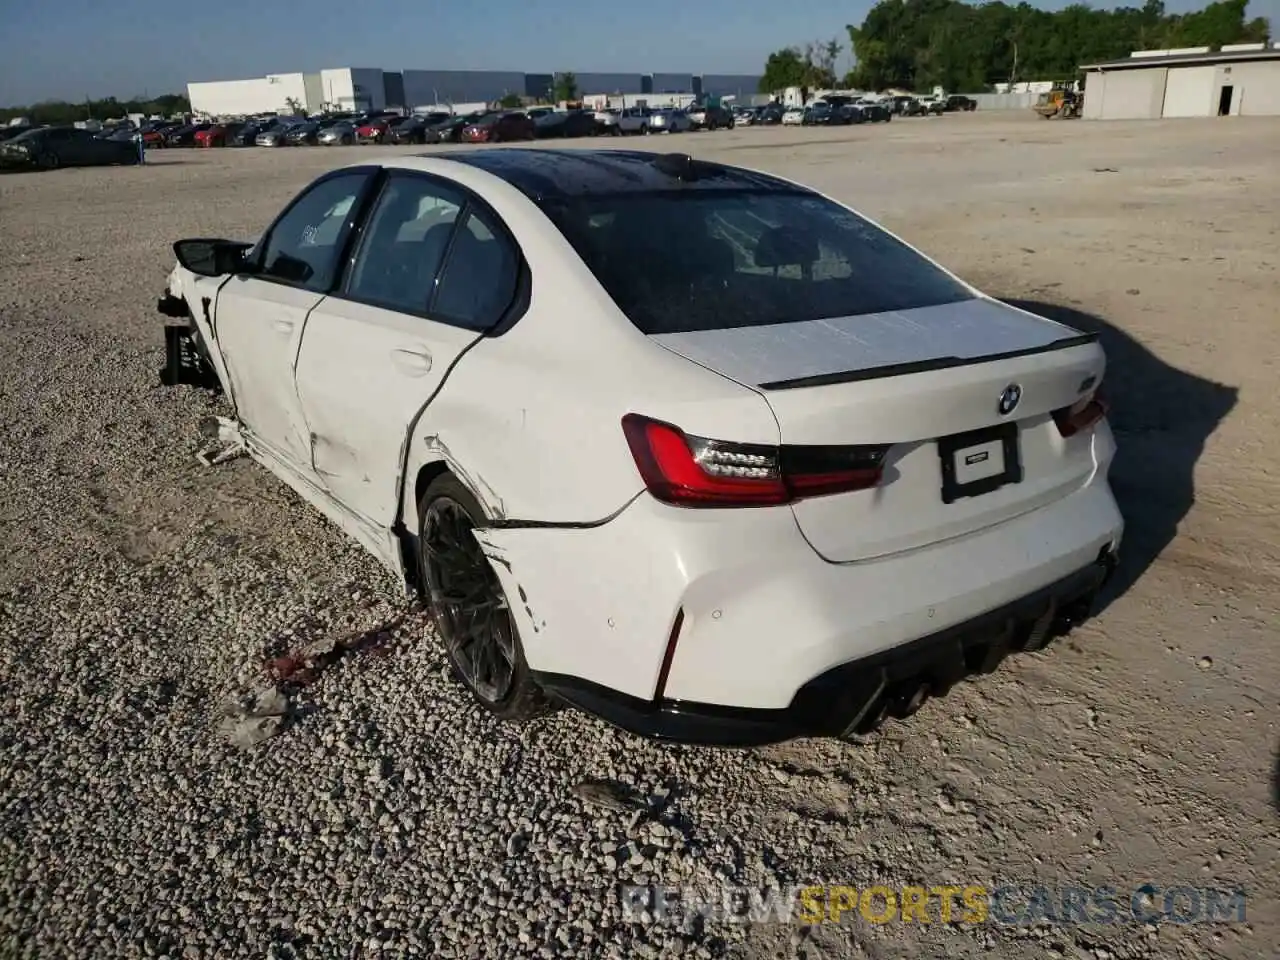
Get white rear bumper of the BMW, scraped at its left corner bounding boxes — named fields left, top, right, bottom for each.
left=477, top=455, right=1124, bottom=742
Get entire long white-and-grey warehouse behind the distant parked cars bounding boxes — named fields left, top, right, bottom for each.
left=187, top=67, right=760, bottom=116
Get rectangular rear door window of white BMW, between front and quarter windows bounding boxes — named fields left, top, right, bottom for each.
left=346, top=177, right=462, bottom=314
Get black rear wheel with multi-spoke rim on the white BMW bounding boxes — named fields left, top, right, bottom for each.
left=416, top=474, right=548, bottom=722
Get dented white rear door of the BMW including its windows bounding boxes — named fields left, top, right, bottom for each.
left=297, top=172, right=522, bottom=529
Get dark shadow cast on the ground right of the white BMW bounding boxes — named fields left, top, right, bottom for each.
left=1007, top=300, right=1239, bottom=608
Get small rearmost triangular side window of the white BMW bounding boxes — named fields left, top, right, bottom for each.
left=431, top=209, right=520, bottom=330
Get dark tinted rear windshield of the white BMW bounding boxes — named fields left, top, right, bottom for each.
left=544, top=189, right=973, bottom=334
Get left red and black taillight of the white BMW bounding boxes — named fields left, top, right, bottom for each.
left=622, top=413, right=888, bottom=507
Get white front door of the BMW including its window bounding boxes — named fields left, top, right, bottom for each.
left=214, top=168, right=374, bottom=477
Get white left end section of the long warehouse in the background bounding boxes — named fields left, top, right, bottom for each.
left=187, top=67, right=389, bottom=116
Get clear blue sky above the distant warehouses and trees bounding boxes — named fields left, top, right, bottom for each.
left=0, top=0, right=1280, bottom=106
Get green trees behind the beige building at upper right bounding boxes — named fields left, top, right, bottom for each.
left=760, top=0, right=1271, bottom=92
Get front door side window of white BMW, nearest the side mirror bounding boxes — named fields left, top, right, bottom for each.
left=254, top=173, right=369, bottom=293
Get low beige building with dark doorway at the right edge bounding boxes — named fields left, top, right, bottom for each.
left=1080, top=44, right=1280, bottom=120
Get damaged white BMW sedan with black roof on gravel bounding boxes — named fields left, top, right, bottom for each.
left=159, top=150, right=1123, bottom=745
